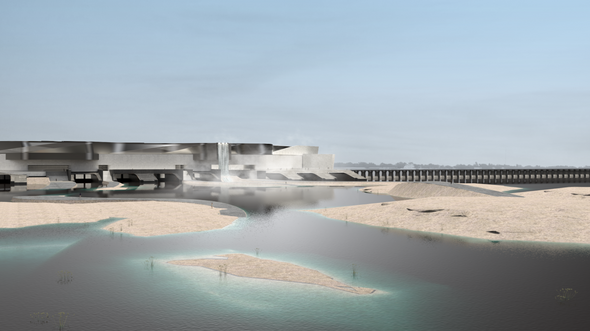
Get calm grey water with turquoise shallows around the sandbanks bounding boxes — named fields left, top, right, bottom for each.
left=0, top=187, right=590, bottom=330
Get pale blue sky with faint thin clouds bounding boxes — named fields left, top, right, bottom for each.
left=0, top=0, right=590, bottom=166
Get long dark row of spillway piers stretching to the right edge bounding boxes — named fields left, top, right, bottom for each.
left=351, top=168, right=590, bottom=184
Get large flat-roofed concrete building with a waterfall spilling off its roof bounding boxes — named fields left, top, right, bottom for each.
left=0, top=141, right=364, bottom=185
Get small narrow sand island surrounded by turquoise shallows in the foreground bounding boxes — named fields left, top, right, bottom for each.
left=168, top=254, right=375, bottom=294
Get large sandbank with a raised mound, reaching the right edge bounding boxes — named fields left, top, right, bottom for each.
left=311, top=183, right=590, bottom=244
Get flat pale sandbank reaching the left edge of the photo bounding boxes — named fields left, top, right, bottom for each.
left=0, top=201, right=238, bottom=237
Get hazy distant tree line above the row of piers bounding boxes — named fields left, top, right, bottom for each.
left=334, top=162, right=589, bottom=169
